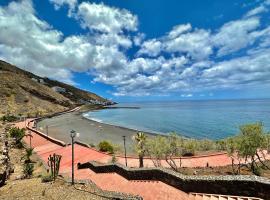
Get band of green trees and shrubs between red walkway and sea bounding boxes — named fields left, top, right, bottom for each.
left=134, top=123, right=270, bottom=175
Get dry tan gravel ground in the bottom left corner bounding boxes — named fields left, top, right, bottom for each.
left=0, top=178, right=108, bottom=200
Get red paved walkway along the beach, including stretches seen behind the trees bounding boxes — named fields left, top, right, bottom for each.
left=16, top=119, right=268, bottom=200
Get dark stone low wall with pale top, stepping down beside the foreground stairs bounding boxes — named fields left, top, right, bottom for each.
left=78, top=162, right=270, bottom=200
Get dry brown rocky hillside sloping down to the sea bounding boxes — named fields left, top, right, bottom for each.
left=0, top=60, right=112, bottom=116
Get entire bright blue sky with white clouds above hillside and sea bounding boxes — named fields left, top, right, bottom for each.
left=0, top=0, right=270, bottom=102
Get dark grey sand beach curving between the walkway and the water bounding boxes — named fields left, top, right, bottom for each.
left=38, top=112, right=155, bottom=154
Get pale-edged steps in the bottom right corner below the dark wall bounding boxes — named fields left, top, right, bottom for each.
left=188, top=192, right=263, bottom=200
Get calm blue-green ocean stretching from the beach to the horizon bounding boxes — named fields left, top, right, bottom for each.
left=83, top=99, right=270, bottom=139
